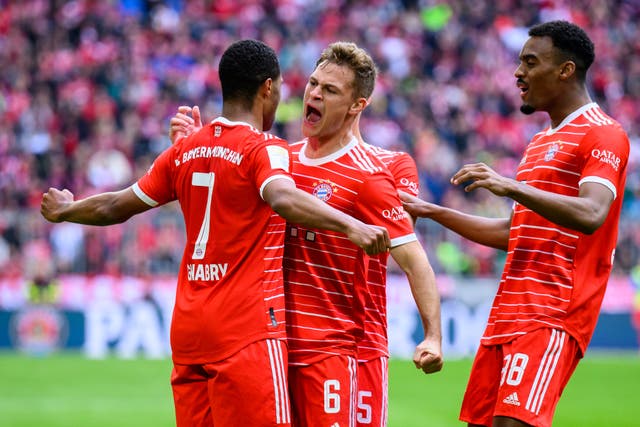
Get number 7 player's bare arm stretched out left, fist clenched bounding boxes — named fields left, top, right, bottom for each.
left=40, top=188, right=151, bottom=225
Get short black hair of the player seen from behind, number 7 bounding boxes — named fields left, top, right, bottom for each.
left=218, top=39, right=280, bottom=108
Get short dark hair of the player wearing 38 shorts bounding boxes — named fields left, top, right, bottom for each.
left=529, top=21, right=596, bottom=81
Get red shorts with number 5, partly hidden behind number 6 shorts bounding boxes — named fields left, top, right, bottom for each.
left=356, top=357, right=389, bottom=427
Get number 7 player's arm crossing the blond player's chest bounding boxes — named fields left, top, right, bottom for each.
left=262, top=178, right=391, bottom=255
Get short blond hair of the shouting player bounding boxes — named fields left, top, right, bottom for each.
left=316, top=41, right=378, bottom=99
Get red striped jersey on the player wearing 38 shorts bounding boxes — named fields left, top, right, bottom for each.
left=482, top=103, right=629, bottom=352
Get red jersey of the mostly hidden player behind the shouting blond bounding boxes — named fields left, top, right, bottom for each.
left=358, top=144, right=420, bottom=361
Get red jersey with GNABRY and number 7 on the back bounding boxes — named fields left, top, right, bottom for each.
left=133, top=118, right=292, bottom=364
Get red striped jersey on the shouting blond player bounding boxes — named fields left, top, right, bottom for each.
left=284, top=138, right=416, bottom=364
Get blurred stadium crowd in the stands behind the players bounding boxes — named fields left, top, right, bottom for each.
left=0, top=0, right=640, bottom=284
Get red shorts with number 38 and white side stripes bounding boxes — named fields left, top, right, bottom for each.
left=460, top=328, right=581, bottom=427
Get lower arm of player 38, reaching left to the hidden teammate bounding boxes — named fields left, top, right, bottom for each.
left=400, top=192, right=511, bottom=251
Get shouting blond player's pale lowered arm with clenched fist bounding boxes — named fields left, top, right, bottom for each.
left=391, top=241, right=443, bottom=374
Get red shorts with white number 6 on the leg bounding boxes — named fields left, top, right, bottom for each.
left=288, top=355, right=358, bottom=427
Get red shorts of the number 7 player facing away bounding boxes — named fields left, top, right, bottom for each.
left=171, top=339, right=291, bottom=427
